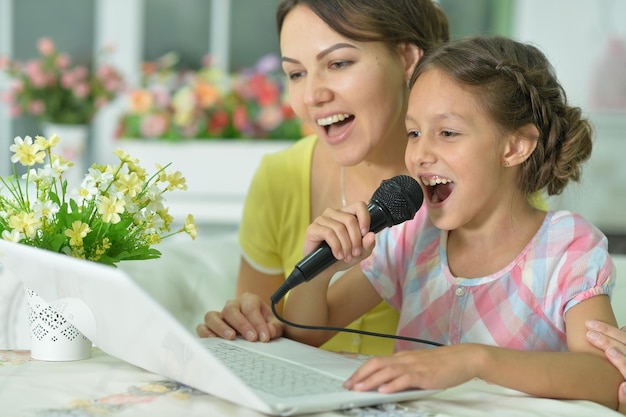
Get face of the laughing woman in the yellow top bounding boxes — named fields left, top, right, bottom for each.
left=280, top=6, right=408, bottom=165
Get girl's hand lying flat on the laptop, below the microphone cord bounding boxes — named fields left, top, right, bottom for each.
left=344, top=344, right=480, bottom=393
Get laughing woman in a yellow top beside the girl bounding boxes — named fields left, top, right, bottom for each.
left=197, top=0, right=449, bottom=354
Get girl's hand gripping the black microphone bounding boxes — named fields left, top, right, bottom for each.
left=304, top=202, right=375, bottom=273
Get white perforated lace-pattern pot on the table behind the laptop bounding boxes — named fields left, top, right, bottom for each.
left=24, top=286, right=92, bottom=361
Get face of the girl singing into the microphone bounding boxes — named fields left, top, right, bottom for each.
left=405, top=69, right=515, bottom=230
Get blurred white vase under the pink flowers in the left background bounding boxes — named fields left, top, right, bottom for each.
left=42, top=123, right=89, bottom=189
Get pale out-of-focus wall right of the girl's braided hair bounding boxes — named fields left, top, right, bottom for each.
left=513, top=0, right=626, bottom=233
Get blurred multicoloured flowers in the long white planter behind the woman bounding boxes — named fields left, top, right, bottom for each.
left=117, top=54, right=307, bottom=141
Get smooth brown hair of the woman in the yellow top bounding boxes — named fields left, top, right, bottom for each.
left=276, top=0, right=450, bottom=52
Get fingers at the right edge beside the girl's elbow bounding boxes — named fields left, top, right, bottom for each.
left=586, top=320, right=626, bottom=414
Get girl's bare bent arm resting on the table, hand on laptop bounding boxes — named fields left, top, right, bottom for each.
left=346, top=295, right=623, bottom=409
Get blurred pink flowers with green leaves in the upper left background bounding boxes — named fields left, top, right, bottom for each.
left=0, top=38, right=124, bottom=124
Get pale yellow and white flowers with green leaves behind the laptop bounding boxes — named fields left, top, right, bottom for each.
left=0, top=135, right=197, bottom=266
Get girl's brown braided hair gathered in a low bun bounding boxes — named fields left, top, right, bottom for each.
left=410, top=36, right=593, bottom=196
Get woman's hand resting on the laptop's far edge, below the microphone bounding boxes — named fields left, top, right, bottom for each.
left=196, top=293, right=283, bottom=342
